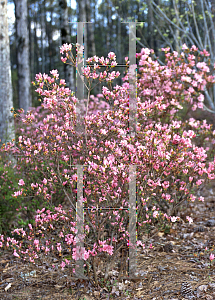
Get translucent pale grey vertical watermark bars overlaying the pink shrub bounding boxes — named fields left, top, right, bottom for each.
left=76, top=22, right=141, bottom=278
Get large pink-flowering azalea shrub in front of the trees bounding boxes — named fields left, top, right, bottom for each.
left=2, top=47, right=215, bottom=276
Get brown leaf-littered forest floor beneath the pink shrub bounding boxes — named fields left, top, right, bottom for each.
left=0, top=181, right=215, bottom=300
